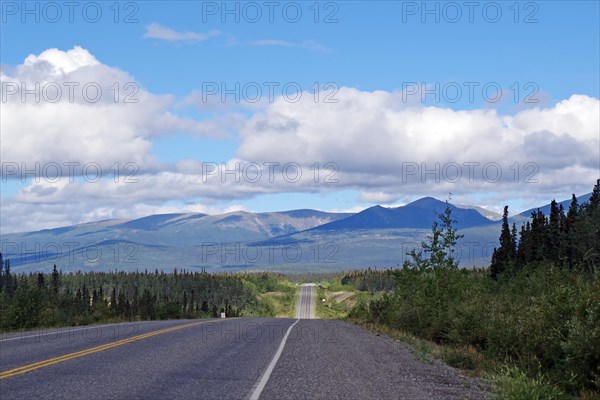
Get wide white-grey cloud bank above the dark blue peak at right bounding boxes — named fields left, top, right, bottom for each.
left=237, top=88, right=600, bottom=201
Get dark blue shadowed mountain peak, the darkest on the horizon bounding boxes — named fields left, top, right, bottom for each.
left=312, top=197, right=494, bottom=231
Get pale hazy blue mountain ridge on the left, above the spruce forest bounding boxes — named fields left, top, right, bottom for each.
left=1, top=210, right=351, bottom=271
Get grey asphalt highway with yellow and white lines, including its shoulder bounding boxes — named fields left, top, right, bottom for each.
left=0, top=287, right=485, bottom=400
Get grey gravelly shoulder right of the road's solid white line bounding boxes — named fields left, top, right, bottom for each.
left=261, top=320, right=492, bottom=400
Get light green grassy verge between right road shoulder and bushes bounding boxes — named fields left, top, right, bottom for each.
left=317, top=274, right=600, bottom=400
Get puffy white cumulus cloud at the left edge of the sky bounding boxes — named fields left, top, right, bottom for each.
left=0, top=46, right=224, bottom=177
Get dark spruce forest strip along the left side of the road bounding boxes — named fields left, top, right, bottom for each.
left=0, top=268, right=282, bottom=330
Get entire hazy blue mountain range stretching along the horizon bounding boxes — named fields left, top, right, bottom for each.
left=1, top=195, right=589, bottom=272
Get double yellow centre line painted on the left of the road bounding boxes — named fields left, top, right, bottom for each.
left=0, top=319, right=220, bottom=379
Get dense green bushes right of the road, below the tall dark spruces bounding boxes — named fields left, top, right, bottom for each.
left=350, top=266, right=600, bottom=392
